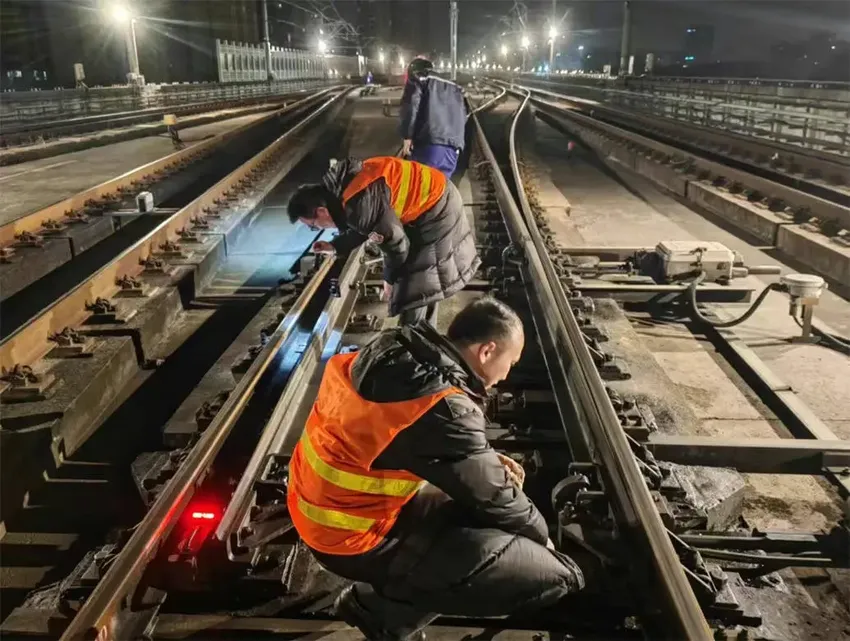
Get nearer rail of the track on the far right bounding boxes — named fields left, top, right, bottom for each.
left=520, top=89, right=850, bottom=229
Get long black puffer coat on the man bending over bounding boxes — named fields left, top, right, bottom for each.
left=323, top=158, right=481, bottom=316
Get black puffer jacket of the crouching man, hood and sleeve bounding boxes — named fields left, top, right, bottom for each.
left=352, top=322, right=548, bottom=544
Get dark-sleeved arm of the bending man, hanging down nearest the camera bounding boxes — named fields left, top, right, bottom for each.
left=345, top=179, right=410, bottom=284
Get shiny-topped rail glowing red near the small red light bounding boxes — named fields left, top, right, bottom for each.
left=54, top=92, right=356, bottom=641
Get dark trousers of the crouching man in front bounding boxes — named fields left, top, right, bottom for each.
left=314, top=486, right=584, bottom=639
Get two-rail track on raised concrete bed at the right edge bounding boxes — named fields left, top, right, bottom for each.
left=498, top=82, right=850, bottom=290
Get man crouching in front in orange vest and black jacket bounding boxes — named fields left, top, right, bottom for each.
left=288, top=298, right=584, bottom=641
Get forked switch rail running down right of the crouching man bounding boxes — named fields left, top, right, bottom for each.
left=475, top=94, right=713, bottom=641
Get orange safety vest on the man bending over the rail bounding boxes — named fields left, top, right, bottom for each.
left=342, top=156, right=446, bottom=224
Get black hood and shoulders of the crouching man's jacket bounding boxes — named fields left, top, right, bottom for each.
left=351, top=321, right=487, bottom=403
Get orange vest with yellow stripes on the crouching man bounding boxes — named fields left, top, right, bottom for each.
left=287, top=354, right=462, bottom=555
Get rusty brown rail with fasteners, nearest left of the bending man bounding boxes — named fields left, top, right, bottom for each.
left=0, top=90, right=350, bottom=369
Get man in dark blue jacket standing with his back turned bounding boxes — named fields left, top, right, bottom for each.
left=400, top=57, right=466, bottom=178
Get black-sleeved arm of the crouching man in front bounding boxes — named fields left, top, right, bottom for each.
left=376, top=396, right=549, bottom=545
